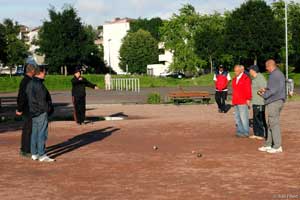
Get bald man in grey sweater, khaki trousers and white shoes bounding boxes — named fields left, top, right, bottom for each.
left=258, top=59, right=286, bottom=153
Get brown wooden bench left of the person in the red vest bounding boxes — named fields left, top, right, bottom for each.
left=168, top=91, right=211, bottom=104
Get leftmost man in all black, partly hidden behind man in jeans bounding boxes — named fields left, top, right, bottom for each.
left=16, top=64, right=34, bottom=157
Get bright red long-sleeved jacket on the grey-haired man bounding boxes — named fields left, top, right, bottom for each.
left=232, top=73, right=252, bottom=105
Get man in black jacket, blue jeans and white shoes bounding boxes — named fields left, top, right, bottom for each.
left=26, top=67, right=55, bottom=162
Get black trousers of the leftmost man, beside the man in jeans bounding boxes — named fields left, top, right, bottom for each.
left=21, top=115, right=32, bottom=153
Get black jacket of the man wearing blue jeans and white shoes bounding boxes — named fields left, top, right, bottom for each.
left=26, top=77, right=54, bottom=117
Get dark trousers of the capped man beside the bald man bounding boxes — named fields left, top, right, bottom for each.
left=252, top=105, right=268, bottom=138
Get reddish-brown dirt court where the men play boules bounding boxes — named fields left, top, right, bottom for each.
left=0, top=102, right=300, bottom=200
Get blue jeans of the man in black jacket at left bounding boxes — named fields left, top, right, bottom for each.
left=31, top=113, right=48, bottom=156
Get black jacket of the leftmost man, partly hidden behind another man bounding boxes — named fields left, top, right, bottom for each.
left=17, top=75, right=32, bottom=115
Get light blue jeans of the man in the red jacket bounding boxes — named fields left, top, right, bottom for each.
left=234, top=105, right=249, bottom=136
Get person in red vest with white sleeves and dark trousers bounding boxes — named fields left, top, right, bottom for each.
left=214, top=65, right=231, bottom=113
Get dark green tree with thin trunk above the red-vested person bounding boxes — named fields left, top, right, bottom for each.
left=195, top=13, right=225, bottom=73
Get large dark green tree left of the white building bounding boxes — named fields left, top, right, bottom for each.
left=38, top=6, right=98, bottom=72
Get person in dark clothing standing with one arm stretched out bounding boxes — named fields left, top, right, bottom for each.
left=71, top=67, right=99, bottom=125
